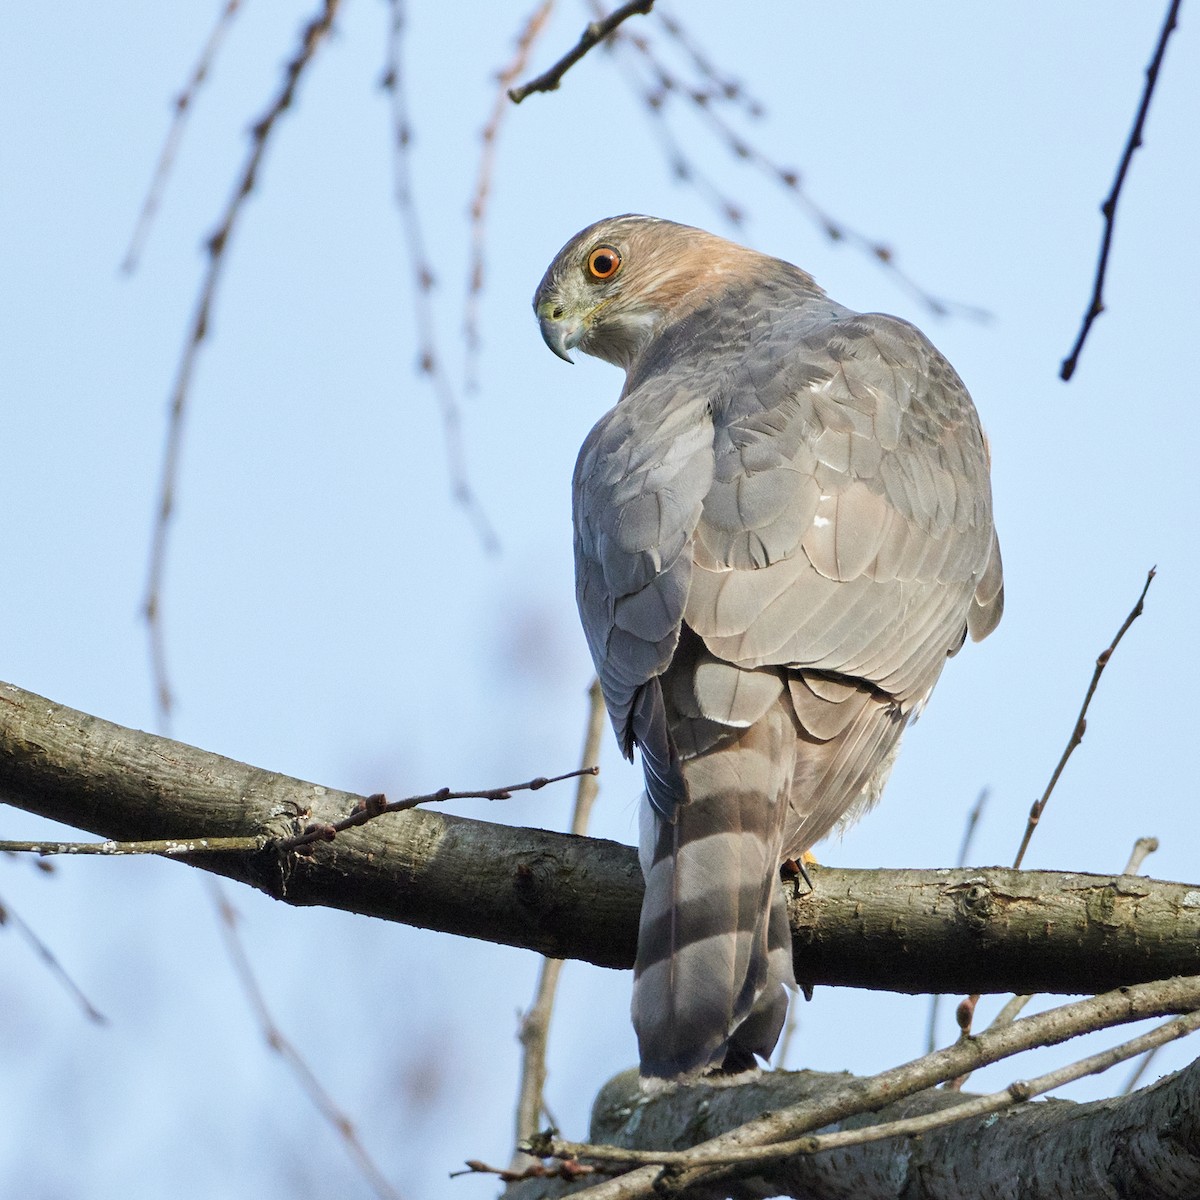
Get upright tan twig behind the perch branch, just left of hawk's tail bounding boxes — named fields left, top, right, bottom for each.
left=510, top=679, right=607, bottom=1171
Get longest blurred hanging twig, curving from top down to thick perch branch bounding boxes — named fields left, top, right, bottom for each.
left=143, top=0, right=341, bottom=728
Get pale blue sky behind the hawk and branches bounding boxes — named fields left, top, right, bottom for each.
left=0, top=0, right=1200, bottom=1200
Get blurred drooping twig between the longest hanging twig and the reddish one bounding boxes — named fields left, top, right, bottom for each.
left=382, top=0, right=500, bottom=553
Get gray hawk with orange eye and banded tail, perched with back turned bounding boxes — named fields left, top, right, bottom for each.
left=534, top=216, right=1003, bottom=1079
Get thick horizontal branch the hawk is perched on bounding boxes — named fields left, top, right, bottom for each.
left=0, top=684, right=1200, bottom=994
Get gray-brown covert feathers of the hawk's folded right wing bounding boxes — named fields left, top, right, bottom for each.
left=685, top=314, right=998, bottom=707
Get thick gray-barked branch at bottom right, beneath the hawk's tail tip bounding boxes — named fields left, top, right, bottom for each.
left=505, top=1063, right=1200, bottom=1200
